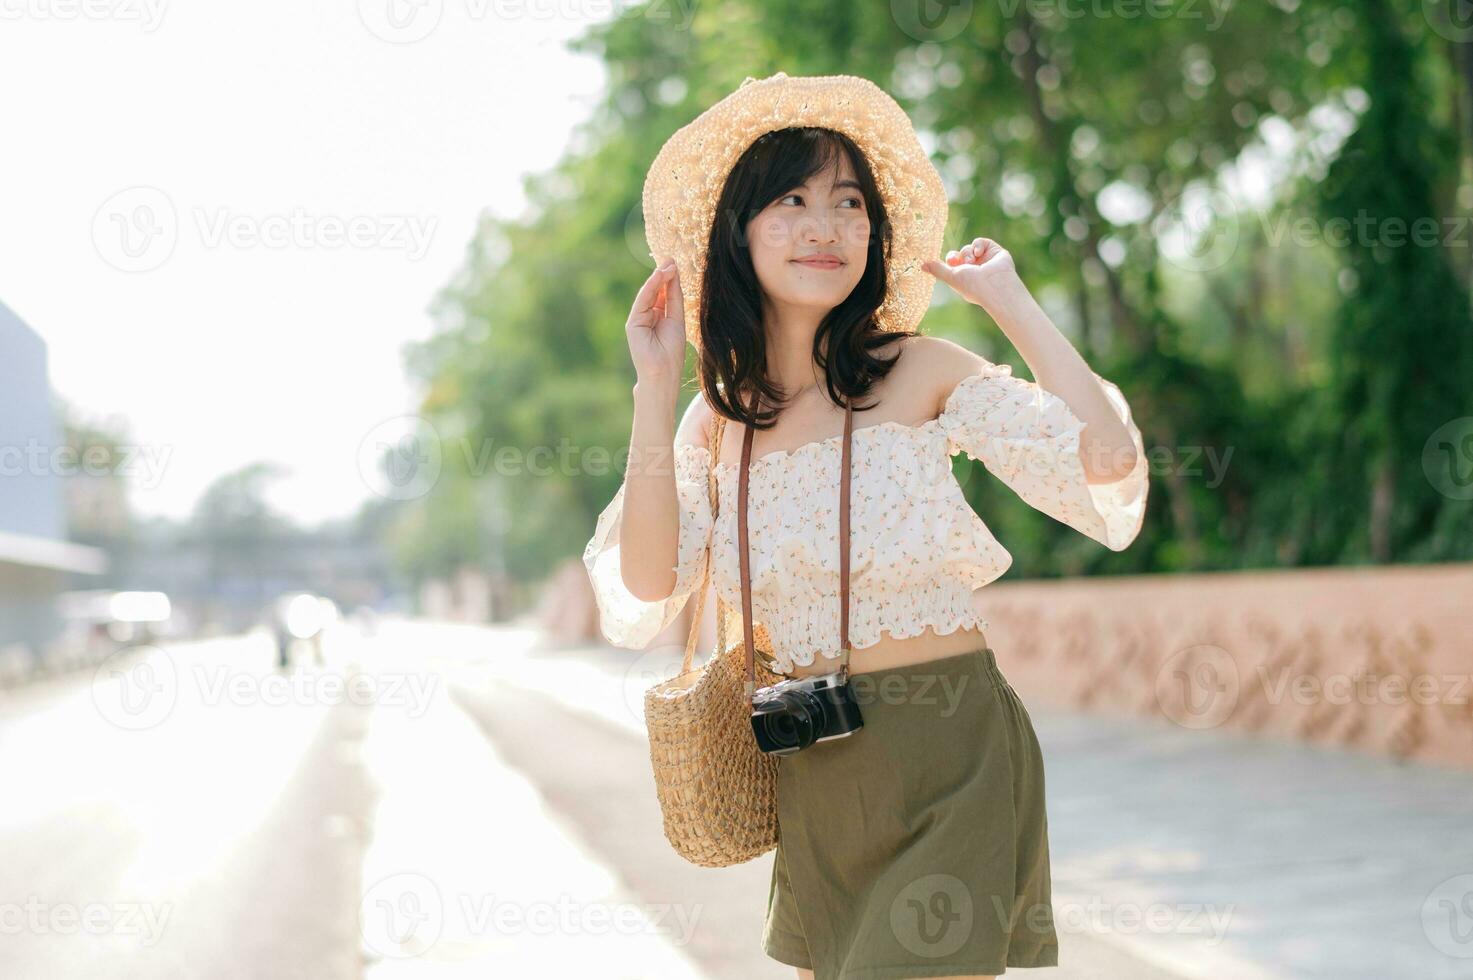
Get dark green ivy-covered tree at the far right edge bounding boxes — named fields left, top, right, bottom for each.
left=1307, top=0, right=1473, bottom=563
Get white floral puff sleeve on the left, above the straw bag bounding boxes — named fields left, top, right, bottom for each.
left=583, top=444, right=713, bottom=650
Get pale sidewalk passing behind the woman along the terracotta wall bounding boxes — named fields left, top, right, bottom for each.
left=468, top=627, right=1473, bottom=980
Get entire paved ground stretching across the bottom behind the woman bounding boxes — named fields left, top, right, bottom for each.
left=0, top=622, right=1473, bottom=980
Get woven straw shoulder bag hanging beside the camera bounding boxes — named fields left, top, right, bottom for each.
left=644, top=416, right=782, bottom=868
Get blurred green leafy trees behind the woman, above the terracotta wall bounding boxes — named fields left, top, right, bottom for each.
left=388, top=0, right=1473, bottom=601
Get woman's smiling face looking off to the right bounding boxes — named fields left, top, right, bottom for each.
left=747, top=156, right=869, bottom=321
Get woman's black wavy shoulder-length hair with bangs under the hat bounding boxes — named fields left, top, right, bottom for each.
left=698, top=127, right=909, bottom=429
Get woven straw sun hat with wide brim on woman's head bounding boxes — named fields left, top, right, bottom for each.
left=644, top=71, right=947, bottom=349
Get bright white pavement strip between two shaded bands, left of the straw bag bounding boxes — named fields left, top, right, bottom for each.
left=350, top=626, right=704, bottom=980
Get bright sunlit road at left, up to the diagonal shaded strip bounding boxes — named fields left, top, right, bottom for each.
left=0, top=623, right=706, bottom=980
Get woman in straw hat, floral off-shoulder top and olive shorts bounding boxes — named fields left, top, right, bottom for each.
left=585, top=72, right=1146, bottom=980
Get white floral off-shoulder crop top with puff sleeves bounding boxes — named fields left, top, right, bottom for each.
left=583, top=363, right=1149, bottom=673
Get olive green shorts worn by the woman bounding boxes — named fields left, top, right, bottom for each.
left=763, top=647, right=1059, bottom=980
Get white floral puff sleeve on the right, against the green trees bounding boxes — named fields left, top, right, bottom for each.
left=938, top=363, right=1149, bottom=551
